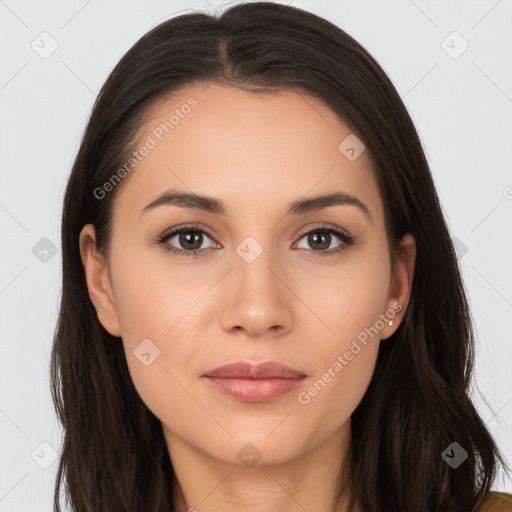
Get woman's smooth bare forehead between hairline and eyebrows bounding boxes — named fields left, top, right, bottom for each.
left=115, top=84, right=383, bottom=226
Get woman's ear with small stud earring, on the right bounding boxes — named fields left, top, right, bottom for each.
left=380, top=233, right=416, bottom=340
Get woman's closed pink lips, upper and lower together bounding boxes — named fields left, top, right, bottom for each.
left=203, top=361, right=306, bottom=402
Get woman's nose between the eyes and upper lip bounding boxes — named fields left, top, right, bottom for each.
left=221, top=251, right=296, bottom=338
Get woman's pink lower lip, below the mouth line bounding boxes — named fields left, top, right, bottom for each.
left=206, top=377, right=305, bottom=402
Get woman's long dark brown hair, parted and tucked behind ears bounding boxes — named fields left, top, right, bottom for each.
left=51, top=2, right=506, bottom=512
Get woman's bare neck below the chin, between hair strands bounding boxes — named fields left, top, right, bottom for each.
left=164, top=422, right=360, bottom=512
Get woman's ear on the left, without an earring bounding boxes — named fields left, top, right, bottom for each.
left=80, top=224, right=121, bottom=336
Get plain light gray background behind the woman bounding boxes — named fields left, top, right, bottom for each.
left=0, top=0, right=512, bottom=512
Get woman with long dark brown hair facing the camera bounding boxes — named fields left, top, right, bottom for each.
left=51, top=3, right=512, bottom=512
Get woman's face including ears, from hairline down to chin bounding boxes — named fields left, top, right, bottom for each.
left=81, top=85, right=413, bottom=464
